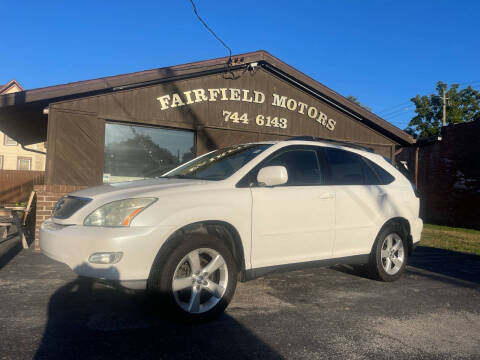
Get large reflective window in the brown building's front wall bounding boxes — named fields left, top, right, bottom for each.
left=103, top=123, right=195, bottom=183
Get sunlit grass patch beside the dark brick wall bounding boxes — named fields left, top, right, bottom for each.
left=420, top=224, right=480, bottom=255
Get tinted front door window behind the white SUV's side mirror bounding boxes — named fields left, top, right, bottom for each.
left=262, top=149, right=322, bottom=186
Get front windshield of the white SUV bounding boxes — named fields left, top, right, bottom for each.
left=162, top=144, right=272, bottom=180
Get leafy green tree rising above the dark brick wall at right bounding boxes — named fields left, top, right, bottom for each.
left=405, top=81, right=480, bottom=137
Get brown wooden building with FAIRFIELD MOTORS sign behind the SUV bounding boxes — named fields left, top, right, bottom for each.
left=0, top=51, right=414, bottom=246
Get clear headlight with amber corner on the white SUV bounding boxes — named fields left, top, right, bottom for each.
left=83, top=198, right=157, bottom=226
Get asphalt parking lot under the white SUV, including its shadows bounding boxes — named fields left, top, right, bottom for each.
left=0, top=238, right=480, bottom=359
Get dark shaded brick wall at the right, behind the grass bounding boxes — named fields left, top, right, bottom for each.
left=401, top=120, right=480, bottom=229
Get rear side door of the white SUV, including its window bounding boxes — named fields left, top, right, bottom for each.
left=324, top=147, right=386, bottom=257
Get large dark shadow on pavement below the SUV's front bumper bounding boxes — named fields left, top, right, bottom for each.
left=34, top=277, right=281, bottom=360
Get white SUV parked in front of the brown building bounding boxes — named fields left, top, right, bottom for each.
left=40, top=138, right=423, bottom=319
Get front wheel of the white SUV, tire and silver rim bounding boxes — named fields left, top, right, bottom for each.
left=147, top=234, right=238, bottom=322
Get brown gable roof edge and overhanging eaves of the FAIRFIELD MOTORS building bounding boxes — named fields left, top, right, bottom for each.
left=0, top=50, right=414, bottom=145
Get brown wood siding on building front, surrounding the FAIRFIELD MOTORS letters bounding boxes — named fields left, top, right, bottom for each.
left=47, top=68, right=397, bottom=185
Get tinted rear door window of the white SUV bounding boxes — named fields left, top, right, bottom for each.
left=325, top=148, right=379, bottom=185
